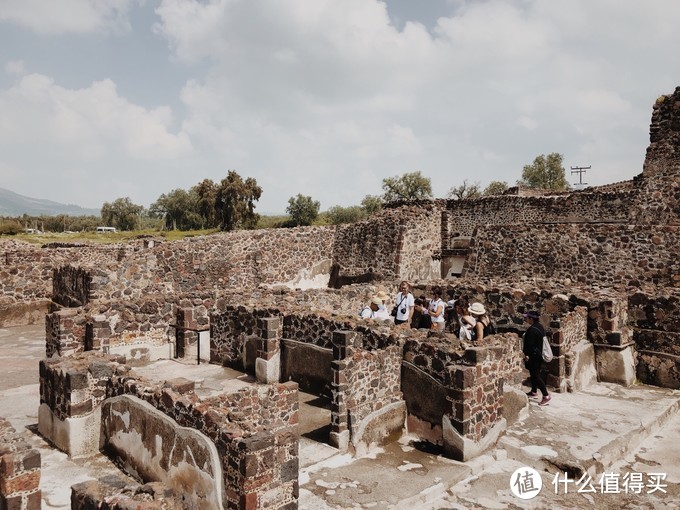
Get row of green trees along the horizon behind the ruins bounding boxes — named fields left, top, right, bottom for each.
left=0, top=149, right=569, bottom=233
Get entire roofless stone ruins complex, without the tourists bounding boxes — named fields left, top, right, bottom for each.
left=0, top=87, right=680, bottom=510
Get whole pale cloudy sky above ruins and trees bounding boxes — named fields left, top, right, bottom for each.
left=0, top=0, right=680, bottom=214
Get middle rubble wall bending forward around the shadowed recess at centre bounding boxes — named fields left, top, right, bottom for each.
left=211, top=306, right=403, bottom=449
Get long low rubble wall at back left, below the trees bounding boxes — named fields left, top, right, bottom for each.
left=0, top=223, right=336, bottom=318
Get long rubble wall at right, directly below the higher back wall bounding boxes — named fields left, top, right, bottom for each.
left=466, top=224, right=680, bottom=288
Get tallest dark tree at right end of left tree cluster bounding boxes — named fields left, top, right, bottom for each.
left=215, top=170, right=262, bottom=231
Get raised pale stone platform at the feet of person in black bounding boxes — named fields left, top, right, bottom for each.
left=497, top=383, right=680, bottom=478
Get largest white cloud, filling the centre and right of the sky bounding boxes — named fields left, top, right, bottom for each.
left=151, top=0, right=678, bottom=206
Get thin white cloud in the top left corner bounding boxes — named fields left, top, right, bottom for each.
left=0, top=0, right=139, bottom=35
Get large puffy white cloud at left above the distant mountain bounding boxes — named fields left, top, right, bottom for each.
left=0, top=69, right=193, bottom=207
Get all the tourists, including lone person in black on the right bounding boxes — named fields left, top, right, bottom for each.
left=360, top=281, right=551, bottom=406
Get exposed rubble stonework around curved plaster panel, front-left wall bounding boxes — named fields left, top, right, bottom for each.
left=40, top=353, right=298, bottom=509
